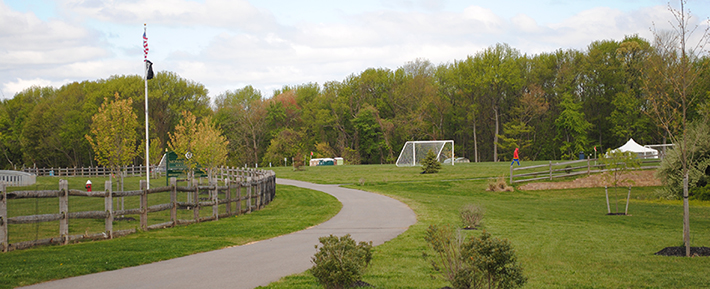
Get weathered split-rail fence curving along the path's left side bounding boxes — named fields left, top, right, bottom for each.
left=0, top=169, right=276, bottom=252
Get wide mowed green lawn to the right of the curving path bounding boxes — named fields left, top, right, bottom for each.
left=267, top=163, right=710, bottom=288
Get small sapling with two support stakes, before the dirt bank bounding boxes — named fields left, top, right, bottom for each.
left=601, top=149, right=641, bottom=214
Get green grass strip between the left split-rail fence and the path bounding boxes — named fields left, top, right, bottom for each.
left=0, top=179, right=341, bottom=288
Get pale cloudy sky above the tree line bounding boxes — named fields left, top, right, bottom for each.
left=0, top=0, right=710, bottom=99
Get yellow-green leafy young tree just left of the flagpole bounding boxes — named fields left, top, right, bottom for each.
left=85, top=93, right=140, bottom=178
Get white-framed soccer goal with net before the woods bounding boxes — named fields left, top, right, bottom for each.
left=396, top=140, right=454, bottom=167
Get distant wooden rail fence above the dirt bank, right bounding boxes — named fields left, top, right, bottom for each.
left=510, top=158, right=661, bottom=185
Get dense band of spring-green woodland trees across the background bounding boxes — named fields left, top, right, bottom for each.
left=0, top=36, right=710, bottom=169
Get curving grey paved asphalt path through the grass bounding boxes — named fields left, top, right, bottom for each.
left=24, top=179, right=416, bottom=289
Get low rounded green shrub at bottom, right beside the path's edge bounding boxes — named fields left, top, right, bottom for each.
left=310, top=234, right=372, bottom=289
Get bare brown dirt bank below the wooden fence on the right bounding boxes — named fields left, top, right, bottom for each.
left=518, top=170, right=661, bottom=191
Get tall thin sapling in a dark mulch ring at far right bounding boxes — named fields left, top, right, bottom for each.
left=644, top=0, right=710, bottom=257
